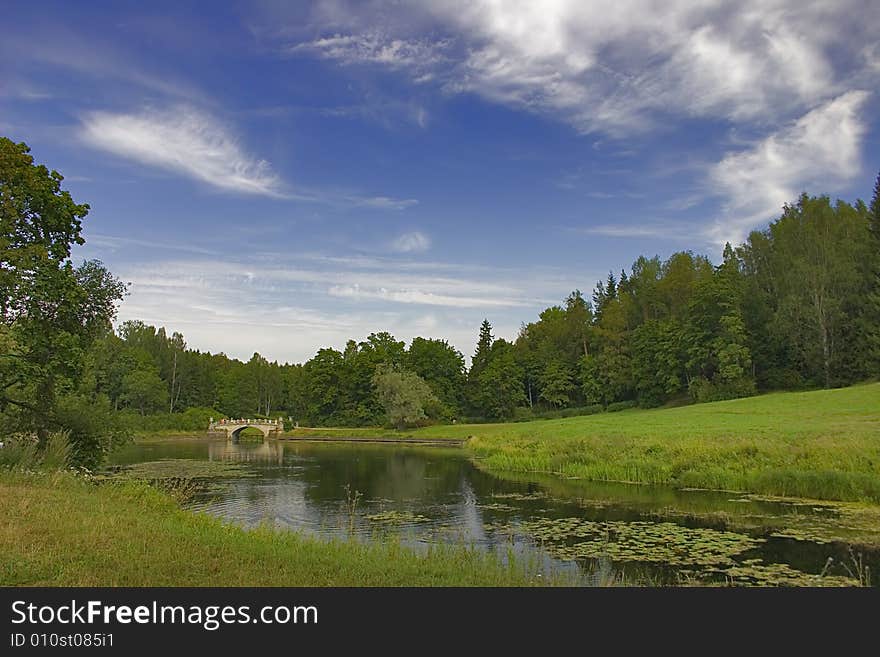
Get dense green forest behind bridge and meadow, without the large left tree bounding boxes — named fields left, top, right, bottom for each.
left=83, top=187, right=880, bottom=426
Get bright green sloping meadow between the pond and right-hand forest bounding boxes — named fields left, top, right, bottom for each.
left=414, top=383, right=880, bottom=503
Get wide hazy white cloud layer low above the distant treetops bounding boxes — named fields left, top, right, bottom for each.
left=101, top=251, right=576, bottom=362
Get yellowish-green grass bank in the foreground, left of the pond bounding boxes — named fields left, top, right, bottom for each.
left=0, top=471, right=563, bottom=586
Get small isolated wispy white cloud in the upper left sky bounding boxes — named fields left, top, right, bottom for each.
left=81, top=106, right=283, bottom=196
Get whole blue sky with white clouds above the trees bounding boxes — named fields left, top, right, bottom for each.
left=0, top=0, right=880, bottom=361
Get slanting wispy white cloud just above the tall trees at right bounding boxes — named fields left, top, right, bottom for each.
left=709, top=91, right=868, bottom=244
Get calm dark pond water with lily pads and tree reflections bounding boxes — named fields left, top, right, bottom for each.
left=113, top=439, right=880, bottom=586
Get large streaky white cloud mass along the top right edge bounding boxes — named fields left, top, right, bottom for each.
left=295, top=0, right=880, bottom=135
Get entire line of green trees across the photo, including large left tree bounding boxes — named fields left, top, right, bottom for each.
left=0, top=132, right=880, bottom=464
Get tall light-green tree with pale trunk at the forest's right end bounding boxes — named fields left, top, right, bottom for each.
left=743, top=195, right=871, bottom=387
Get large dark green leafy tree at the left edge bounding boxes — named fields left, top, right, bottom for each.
left=0, top=137, right=125, bottom=463
